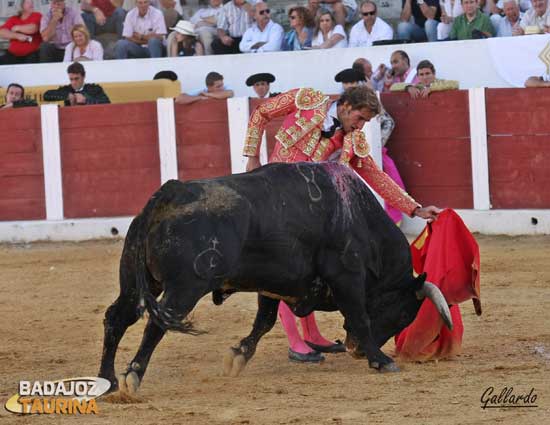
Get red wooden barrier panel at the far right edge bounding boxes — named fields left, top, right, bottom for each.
left=485, top=88, right=550, bottom=209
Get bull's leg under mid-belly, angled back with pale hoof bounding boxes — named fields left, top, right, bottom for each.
left=223, top=295, right=279, bottom=376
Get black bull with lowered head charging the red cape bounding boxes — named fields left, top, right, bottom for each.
left=99, top=163, right=452, bottom=392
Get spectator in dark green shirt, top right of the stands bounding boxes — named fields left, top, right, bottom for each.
left=449, top=0, right=498, bottom=40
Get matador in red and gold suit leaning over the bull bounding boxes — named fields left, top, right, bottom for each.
left=243, top=86, right=441, bottom=362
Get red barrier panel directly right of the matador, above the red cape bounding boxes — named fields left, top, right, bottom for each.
left=382, top=91, right=473, bottom=208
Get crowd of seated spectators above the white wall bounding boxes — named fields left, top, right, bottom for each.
left=0, top=0, right=550, bottom=64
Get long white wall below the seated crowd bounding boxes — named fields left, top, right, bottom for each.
left=0, top=34, right=550, bottom=96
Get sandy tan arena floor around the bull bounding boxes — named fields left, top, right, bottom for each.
left=0, top=236, right=550, bottom=425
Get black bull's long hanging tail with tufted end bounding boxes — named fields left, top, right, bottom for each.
left=135, top=181, right=203, bottom=335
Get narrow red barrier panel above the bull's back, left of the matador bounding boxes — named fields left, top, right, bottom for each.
left=175, top=100, right=231, bottom=180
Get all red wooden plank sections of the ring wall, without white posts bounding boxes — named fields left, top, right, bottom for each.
left=4, top=89, right=550, bottom=221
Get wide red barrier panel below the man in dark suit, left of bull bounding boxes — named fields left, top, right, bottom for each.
left=59, top=102, right=160, bottom=218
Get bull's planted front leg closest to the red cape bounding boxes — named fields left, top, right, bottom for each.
left=330, top=273, right=399, bottom=372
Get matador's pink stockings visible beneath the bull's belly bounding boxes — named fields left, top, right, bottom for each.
left=279, top=301, right=333, bottom=354
